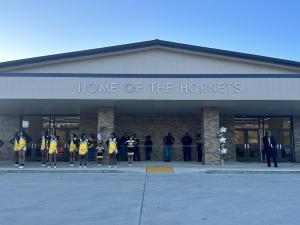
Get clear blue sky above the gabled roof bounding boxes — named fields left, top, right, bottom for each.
left=0, top=0, right=300, bottom=62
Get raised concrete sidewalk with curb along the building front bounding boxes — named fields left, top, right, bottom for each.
left=0, top=161, right=300, bottom=174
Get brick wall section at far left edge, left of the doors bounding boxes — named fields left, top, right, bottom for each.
left=0, top=115, right=21, bottom=161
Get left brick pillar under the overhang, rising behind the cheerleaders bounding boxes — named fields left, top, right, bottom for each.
left=98, top=107, right=115, bottom=143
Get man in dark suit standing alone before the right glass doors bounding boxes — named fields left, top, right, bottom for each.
left=263, top=132, right=277, bottom=167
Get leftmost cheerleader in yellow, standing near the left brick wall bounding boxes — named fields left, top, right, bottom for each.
left=10, top=130, right=31, bottom=169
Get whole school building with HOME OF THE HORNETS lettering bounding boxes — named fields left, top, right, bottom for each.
left=0, top=40, right=300, bottom=165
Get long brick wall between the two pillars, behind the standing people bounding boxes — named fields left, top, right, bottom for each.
left=115, top=113, right=201, bottom=161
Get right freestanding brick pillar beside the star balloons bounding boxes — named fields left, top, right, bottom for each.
left=201, top=107, right=221, bottom=165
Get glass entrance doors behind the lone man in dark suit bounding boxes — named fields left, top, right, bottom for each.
left=235, top=117, right=294, bottom=162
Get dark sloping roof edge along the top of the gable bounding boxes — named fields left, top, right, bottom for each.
left=0, top=39, right=300, bottom=69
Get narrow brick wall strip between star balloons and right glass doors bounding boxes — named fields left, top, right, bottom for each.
left=220, top=114, right=236, bottom=162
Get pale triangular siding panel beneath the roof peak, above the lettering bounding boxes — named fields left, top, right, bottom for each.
left=2, top=48, right=300, bottom=74
